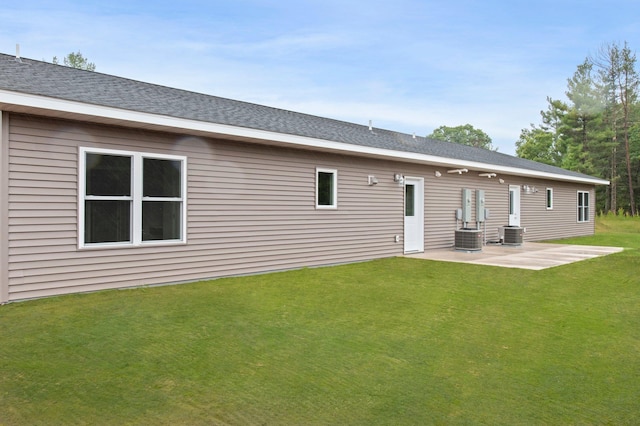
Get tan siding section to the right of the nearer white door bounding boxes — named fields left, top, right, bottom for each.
left=406, top=166, right=595, bottom=250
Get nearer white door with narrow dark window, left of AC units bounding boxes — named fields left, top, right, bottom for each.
left=404, top=177, right=424, bottom=253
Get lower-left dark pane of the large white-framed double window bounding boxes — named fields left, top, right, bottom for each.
left=84, top=200, right=131, bottom=243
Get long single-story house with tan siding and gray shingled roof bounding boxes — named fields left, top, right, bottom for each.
left=0, top=54, right=608, bottom=303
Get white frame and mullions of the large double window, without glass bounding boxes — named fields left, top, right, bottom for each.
left=78, top=147, right=187, bottom=249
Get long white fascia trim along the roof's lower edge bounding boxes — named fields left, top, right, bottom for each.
left=0, top=90, right=609, bottom=185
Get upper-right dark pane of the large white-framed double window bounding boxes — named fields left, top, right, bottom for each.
left=142, top=158, right=182, bottom=198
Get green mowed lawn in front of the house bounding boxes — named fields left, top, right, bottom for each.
left=0, top=218, right=640, bottom=425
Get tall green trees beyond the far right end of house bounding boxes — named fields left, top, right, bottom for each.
left=516, top=42, right=640, bottom=216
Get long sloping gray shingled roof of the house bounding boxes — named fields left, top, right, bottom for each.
left=0, top=54, right=608, bottom=184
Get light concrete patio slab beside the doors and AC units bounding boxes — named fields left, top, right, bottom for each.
left=406, top=242, right=623, bottom=270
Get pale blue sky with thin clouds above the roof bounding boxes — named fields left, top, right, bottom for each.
left=0, top=0, right=640, bottom=154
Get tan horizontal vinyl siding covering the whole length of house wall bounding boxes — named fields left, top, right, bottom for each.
left=0, top=113, right=595, bottom=300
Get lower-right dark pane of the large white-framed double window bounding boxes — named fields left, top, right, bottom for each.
left=142, top=201, right=182, bottom=241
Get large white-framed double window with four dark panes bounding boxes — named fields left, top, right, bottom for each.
left=78, top=147, right=187, bottom=248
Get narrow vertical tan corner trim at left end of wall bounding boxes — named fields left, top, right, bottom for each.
left=0, top=110, right=9, bottom=305
